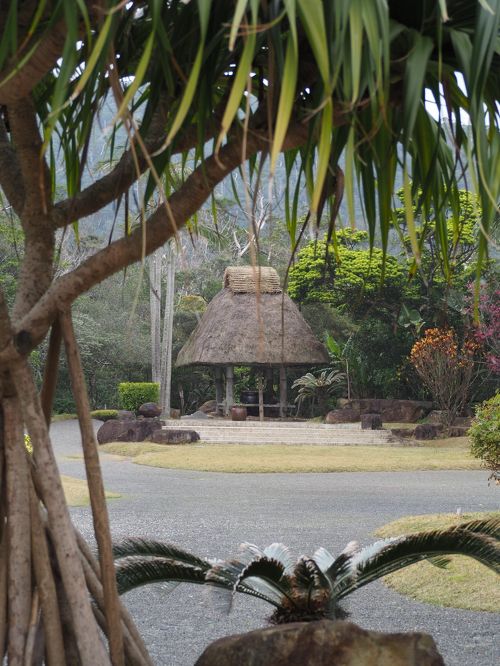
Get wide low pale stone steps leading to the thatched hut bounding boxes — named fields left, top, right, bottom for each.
left=165, top=418, right=394, bottom=446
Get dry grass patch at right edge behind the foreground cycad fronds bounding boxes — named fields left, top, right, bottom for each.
left=376, top=512, right=500, bottom=612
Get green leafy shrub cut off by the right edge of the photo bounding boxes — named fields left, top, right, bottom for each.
left=469, top=391, right=500, bottom=483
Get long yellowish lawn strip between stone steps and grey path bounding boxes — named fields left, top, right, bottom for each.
left=99, top=442, right=480, bottom=473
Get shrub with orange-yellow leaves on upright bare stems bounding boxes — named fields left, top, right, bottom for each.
left=410, top=328, right=480, bottom=425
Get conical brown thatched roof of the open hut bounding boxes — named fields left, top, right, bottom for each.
left=176, top=267, right=328, bottom=366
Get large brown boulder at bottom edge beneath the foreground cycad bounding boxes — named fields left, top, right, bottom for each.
left=195, top=620, right=444, bottom=666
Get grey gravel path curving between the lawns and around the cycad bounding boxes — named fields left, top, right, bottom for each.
left=52, top=422, right=500, bottom=666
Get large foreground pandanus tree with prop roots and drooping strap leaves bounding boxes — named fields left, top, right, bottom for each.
left=0, top=0, right=500, bottom=666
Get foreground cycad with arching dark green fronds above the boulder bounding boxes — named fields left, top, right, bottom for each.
left=114, top=518, right=500, bottom=624
